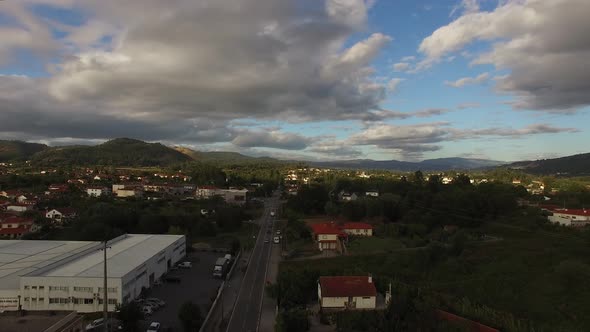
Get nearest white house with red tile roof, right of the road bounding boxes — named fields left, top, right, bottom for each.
left=318, top=275, right=377, bottom=310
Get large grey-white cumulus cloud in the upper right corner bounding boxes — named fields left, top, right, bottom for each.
left=419, top=0, right=590, bottom=112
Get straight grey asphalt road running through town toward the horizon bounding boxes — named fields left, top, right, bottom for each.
left=226, top=194, right=279, bottom=332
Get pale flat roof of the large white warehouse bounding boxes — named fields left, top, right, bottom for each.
left=0, top=234, right=184, bottom=290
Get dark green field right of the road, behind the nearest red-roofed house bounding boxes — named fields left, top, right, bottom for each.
left=281, top=224, right=590, bottom=331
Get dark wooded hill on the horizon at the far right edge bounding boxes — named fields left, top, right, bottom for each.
left=507, top=153, right=590, bottom=175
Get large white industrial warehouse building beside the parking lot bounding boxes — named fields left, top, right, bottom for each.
left=0, top=234, right=186, bottom=312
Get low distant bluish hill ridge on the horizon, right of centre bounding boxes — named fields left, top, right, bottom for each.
left=311, top=158, right=503, bottom=172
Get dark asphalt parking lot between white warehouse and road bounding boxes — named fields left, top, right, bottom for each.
left=140, top=252, right=223, bottom=331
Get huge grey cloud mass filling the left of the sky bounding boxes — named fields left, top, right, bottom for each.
left=0, top=0, right=391, bottom=148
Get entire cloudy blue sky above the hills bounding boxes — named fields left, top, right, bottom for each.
left=0, top=0, right=590, bottom=161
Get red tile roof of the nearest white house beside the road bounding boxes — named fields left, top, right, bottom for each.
left=320, top=276, right=377, bottom=297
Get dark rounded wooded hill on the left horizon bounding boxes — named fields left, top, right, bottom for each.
left=32, top=138, right=191, bottom=166
